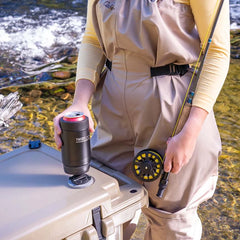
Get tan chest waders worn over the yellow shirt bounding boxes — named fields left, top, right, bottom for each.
left=91, top=0, right=221, bottom=240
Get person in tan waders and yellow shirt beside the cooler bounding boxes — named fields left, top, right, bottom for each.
left=54, top=0, right=230, bottom=240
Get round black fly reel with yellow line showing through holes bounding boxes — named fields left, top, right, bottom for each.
left=133, top=149, right=163, bottom=182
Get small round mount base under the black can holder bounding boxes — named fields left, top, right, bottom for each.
left=68, top=174, right=95, bottom=188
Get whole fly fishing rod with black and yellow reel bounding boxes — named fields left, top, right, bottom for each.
left=133, top=0, right=224, bottom=197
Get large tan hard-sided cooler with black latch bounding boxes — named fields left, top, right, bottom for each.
left=0, top=144, right=148, bottom=240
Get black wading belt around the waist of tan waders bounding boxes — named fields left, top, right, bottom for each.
left=106, top=59, right=189, bottom=77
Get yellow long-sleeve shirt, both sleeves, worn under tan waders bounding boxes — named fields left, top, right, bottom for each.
left=76, top=0, right=230, bottom=112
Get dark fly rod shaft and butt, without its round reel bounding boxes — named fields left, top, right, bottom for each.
left=157, top=0, right=224, bottom=197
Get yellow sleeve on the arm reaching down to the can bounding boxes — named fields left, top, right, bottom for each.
left=76, top=0, right=106, bottom=86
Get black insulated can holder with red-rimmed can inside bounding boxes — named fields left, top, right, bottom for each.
left=60, top=112, right=91, bottom=175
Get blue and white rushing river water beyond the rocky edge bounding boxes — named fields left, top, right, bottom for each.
left=0, top=0, right=240, bottom=87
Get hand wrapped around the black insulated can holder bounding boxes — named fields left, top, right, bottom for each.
left=53, top=104, right=94, bottom=149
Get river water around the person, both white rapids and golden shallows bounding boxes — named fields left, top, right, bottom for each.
left=0, top=0, right=240, bottom=240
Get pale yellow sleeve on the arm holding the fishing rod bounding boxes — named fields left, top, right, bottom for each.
left=190, top=0, right=230, bottom=112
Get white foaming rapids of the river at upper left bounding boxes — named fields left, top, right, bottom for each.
left=0, top=9, right=86, bottom=63
